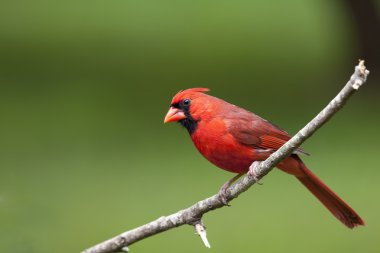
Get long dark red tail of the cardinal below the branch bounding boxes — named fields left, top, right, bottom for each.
left=279, top=155, right=364, bottom=228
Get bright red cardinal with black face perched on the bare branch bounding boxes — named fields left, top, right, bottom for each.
left=164, top=88, right=364, bottom=228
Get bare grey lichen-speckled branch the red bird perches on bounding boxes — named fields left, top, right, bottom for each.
left=82, top=60, right=369, bottom=253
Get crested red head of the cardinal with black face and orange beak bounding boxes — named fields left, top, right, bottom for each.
left=164, top=88, right=209, bottom=134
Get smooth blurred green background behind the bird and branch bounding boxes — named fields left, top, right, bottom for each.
left=0, top=0, right=380, bottom=253
